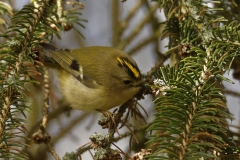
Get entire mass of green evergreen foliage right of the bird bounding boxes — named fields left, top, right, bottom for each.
left=149, top=0, right=240, bottom=160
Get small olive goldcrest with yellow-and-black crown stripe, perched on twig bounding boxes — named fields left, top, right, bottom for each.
left=40, top=43, right=142, bottom=111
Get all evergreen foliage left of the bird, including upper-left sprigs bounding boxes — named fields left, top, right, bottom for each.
left=0, top=1, right=85, bottom=159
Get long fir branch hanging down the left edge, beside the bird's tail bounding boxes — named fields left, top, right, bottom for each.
left=0, top=1, right=59, bottom=159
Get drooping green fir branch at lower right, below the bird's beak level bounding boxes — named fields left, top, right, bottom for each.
left=147, top=66, right=230, bottom=159
